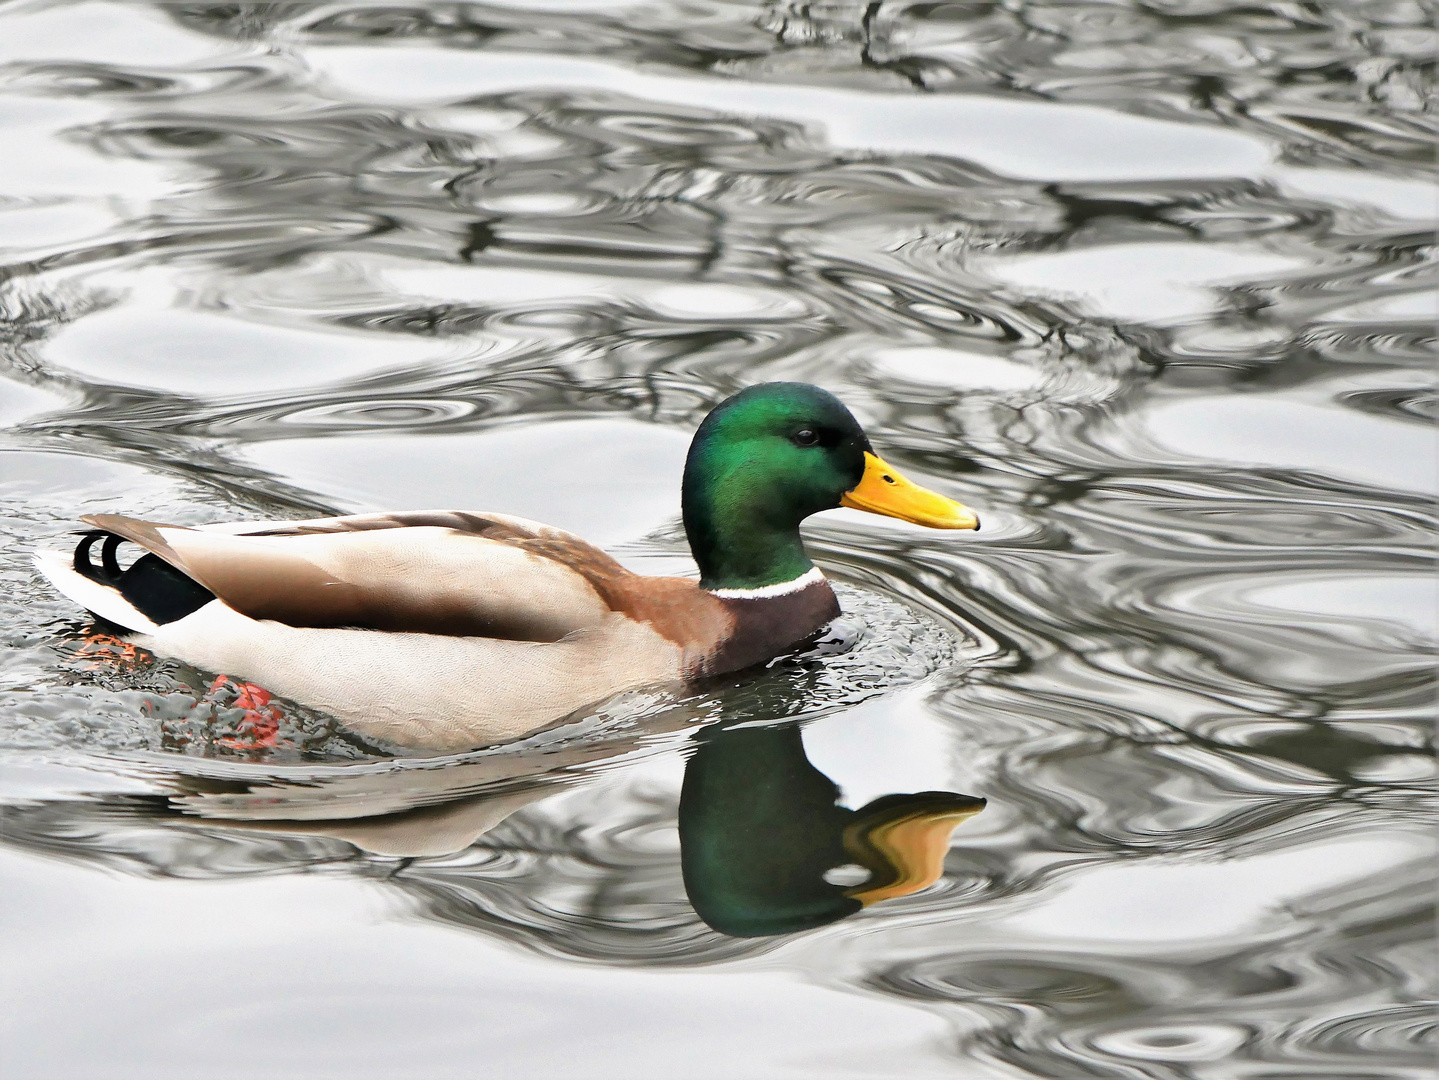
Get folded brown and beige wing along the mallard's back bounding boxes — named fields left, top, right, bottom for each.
left=61, top=511, right=627, bottom=641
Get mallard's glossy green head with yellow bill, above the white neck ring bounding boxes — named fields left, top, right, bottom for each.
left=684, top=383, right=979, bottom=588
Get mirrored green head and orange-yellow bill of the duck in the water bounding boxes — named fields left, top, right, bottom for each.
left=679, top=723, right=984, bottom=938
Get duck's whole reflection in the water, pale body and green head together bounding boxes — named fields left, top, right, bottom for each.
left=151, top=701, right=984, bottom=938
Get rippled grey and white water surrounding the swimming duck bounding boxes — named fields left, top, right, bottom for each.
left=0, top=0, right=1436, bottom=1080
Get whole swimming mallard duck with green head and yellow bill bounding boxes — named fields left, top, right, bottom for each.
left=36, top=383, right=979, bottom=749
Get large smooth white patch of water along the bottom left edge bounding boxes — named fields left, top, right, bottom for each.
left=3, top=854, right=953, bottom=1080
